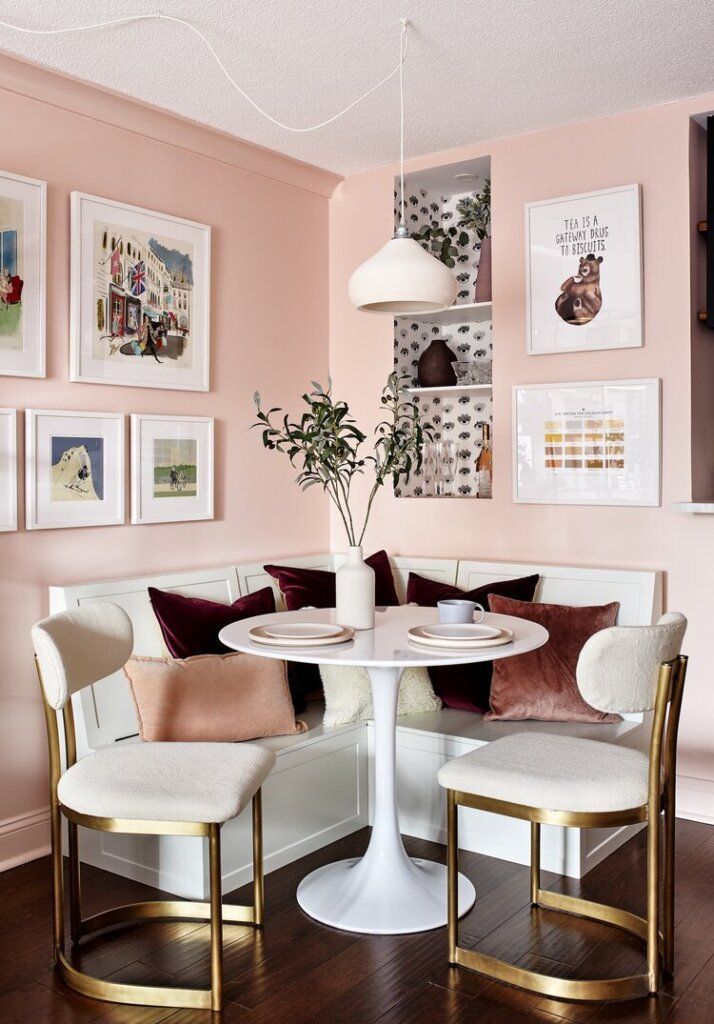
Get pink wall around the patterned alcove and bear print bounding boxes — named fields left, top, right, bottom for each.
left=330, top=94, right=714, bottom=821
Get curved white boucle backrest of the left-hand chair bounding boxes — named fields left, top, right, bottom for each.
left=32, top=601, right=133, bottom=711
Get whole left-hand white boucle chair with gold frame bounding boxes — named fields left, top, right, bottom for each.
left=32, top=601, right=276, bottom=1011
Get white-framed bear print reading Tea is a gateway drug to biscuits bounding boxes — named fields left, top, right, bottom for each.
left=526, top=185, right=644, bottom=355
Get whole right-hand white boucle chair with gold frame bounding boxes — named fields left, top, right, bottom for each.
left=438, top=612, right=686, bottom=1001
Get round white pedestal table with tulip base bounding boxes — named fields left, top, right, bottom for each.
left=219, top=605, right=548, bottom=935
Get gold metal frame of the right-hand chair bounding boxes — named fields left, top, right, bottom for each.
left=447, top=654, right=687, bottom=1002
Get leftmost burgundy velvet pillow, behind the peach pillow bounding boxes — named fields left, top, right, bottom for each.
left=149, top=587, right=309, bottom=712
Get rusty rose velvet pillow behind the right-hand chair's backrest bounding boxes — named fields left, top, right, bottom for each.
left=485, top=595, right=620, bottom=722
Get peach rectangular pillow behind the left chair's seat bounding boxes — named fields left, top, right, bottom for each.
left=124, top=653, right=307, bottom=742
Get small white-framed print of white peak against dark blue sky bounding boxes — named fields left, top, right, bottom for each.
left=25, top=409, right=125, bottom=529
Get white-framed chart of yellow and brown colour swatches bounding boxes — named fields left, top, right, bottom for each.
left=513, top=379, right=661, bottom=506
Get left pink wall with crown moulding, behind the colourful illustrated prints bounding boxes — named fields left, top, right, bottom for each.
left=0, top=57, right=339, bottom=867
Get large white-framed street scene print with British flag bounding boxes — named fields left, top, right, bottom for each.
left=70, top=193, right=211, bottom=391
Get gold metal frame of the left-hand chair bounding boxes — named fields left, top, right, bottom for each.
left=35, top=657, right=264, bottom=1011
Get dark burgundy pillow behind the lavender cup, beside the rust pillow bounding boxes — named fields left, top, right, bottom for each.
left=407, top=572, right=540, bottom=712
